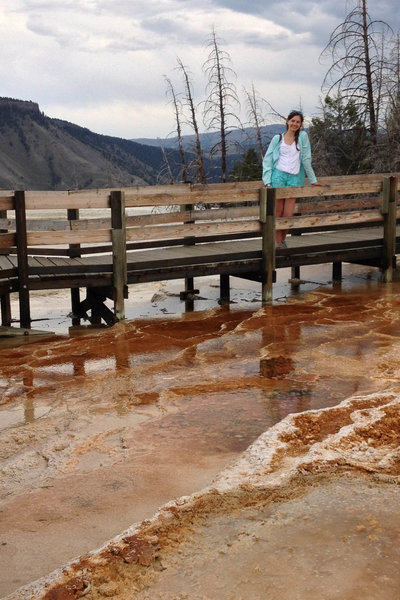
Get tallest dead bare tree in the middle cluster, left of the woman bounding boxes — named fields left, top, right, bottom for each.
left=203, top=29, right=240, bottom=182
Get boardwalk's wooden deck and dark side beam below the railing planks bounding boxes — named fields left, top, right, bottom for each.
left=0, top=225, right=400, bottom=291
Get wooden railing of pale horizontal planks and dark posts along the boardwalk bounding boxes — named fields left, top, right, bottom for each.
left=0, top=174, right=400, bottom=326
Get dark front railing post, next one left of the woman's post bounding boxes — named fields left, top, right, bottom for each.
left=110, top=191, right=128, bottom=321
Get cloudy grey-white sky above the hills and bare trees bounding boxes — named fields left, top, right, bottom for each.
left=0, top=0, right=400, bottom=139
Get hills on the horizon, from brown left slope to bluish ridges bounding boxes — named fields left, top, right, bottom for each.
left=0, top=98, right=282, bottom=190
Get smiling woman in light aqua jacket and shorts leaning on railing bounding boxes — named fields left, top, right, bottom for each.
left=262, top=110, right=321, bottom=248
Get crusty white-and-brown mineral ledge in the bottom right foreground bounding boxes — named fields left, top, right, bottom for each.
left=7, top=390, right=400, bottom=600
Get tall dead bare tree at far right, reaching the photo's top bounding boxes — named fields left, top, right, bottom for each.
left=321, top=0, right=392, bottom=145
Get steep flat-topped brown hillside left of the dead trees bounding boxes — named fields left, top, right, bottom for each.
left=0, top=98, right=167, bottom=190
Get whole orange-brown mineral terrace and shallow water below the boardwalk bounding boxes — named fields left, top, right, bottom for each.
left=0, top=266, right=400, bottom=600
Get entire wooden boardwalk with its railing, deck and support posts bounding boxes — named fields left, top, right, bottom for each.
left=0, top=174, right=400, bottom=329
